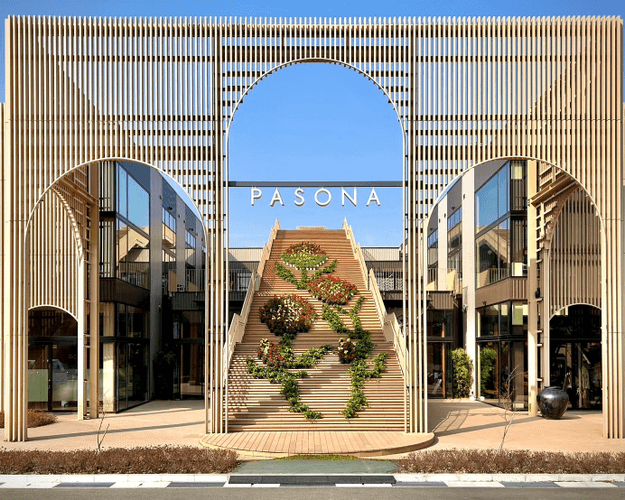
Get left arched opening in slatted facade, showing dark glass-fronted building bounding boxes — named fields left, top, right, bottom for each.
left=26, top=158, right=206, bottom=419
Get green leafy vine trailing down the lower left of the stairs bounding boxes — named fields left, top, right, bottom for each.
left=247, top=334, right=332, bottom=420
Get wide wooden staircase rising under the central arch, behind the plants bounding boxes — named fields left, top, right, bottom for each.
left=228, top=229, right=404, bottom=432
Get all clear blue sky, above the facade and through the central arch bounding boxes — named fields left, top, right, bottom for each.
left=0, top=0, right=625, bottom=246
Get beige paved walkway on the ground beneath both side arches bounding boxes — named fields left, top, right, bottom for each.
left=0, top=400, right=625, bottom=458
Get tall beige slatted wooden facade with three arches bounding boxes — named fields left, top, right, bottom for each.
left=0, top=17, right=625, bottom=440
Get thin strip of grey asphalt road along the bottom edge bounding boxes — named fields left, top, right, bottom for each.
left=0, top=486, right=623, bottom=500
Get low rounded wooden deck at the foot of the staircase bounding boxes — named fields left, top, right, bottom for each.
left=200, top=431, right=434, bottom=458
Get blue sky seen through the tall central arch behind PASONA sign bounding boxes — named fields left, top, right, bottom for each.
left=226, top=60, right=405, bottom=247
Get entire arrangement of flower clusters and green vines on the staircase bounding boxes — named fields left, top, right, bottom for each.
left=247, top=242, right=388, bottom=420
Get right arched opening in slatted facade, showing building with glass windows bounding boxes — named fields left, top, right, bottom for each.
left=423, top=157, right=605, bottom=422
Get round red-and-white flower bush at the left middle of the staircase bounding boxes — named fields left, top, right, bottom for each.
left=260, top=295, right=317, bottom=335
